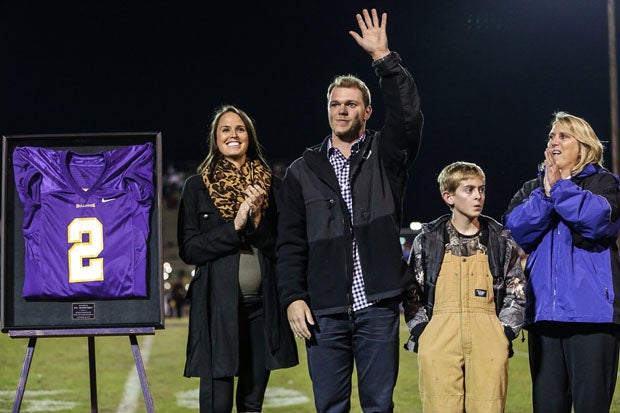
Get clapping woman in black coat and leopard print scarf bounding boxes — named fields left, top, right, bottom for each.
left=178, top=106, right=298, bottom=412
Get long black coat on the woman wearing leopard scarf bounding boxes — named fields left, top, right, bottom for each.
left=177, top=175, right=298, bottom=378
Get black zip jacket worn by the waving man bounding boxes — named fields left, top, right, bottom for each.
left=277, top=53, right=423, bottom=315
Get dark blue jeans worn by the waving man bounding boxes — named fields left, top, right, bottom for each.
left=306, top=300, right=400, bottom=413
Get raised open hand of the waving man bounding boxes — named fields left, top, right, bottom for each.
left=349, top=9, right=390, bottom=60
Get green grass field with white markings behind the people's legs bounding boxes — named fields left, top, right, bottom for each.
left=0, top=318, right=620, bottom=413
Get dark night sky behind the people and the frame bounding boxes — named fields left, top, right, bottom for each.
left=0, top=0, right=620, bottom=225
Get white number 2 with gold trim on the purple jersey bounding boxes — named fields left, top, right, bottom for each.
left=67, top=218, right=103, bottom=283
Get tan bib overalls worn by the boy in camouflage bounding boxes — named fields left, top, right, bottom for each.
left=418, top=251, right=508, bottom=413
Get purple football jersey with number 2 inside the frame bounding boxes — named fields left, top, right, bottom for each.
left=13, top=143, right=155, bottom=299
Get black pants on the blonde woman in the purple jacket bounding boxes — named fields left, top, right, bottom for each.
left=528, top=322, right=620, bottom=413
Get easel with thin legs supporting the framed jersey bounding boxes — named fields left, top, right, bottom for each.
left=9, top=327, right=155, bottom=413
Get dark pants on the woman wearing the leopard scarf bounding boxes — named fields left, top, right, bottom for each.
left=199, top=299, right=269, bottom=413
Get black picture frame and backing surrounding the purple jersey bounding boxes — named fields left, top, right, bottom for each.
left=0, top=132, right=164, bottom=333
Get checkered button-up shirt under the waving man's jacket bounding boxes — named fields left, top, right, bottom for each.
left=327, top=135, right=374, bottom=311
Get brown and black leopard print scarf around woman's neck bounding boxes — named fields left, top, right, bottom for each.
left=202, top=158, right=271, bottom=221
